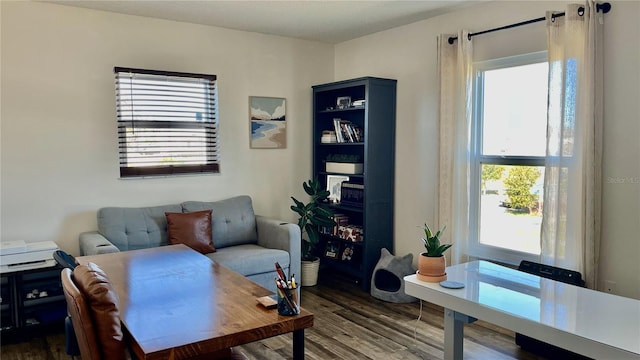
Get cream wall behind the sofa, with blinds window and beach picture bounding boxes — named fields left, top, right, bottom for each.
left=0, top=1, right=334, bottom=254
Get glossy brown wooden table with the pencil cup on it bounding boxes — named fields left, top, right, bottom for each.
left=76, top=245, right=313, bottom=359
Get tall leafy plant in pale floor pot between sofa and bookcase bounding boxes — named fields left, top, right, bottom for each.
left=291, top=179, right=336, bottom=286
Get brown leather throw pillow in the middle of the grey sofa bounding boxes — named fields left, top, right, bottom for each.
left=165, top=210, right=216, bottom=254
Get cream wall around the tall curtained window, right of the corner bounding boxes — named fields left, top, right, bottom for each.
left=335, top=1, right=640, bottom=298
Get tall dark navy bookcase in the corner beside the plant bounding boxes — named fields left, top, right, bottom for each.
left=312, top=77, right=396, bottom=291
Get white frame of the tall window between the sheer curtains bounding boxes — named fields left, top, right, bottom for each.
left=469, top=51, right=548, bottom=265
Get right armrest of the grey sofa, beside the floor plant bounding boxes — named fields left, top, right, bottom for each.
left=256, top=215, right=302, bottom=279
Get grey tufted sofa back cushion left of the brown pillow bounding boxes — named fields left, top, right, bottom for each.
left=98, top=204, right=182, bottom=251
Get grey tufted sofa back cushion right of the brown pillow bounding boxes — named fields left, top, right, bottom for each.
left=182, top=195, right=258, bottom=250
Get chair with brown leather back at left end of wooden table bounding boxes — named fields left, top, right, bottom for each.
left=61, top=263, right=247, bottom=360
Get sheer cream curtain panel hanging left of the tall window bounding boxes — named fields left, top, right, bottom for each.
left=438, top=30, right=473, bottom=264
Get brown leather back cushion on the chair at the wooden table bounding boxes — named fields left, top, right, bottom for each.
left=73, top=263, right=125, bottom=359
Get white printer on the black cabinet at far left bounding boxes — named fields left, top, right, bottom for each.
left=0, top=240, right=59, bottom=274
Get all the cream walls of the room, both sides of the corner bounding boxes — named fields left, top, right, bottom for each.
left=0, top=1, right=640, bottom=298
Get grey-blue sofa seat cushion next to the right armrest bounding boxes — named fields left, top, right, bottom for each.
left=207, top=244, right=289, bottom=276
